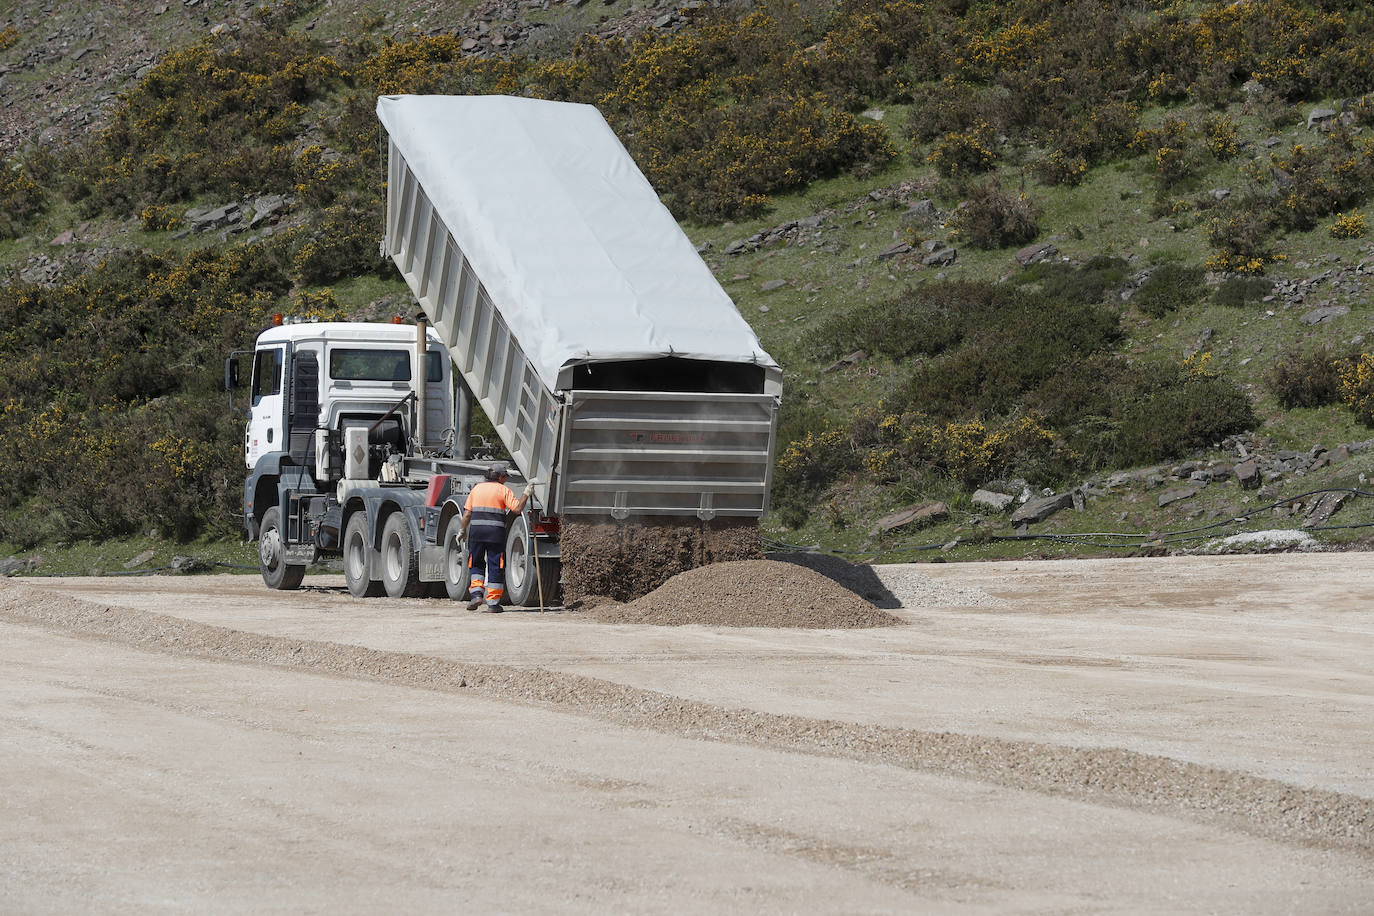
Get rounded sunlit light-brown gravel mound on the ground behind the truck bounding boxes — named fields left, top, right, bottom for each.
left=591, top=560, right=901, bottom=629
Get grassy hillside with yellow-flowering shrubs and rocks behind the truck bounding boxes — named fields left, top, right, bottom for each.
left=0, top=0, right=1374, bottom=565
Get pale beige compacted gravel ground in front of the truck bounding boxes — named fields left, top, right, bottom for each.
left=0, top=553, right=1374, bottom=913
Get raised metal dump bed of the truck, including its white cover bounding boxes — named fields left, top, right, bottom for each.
left=376, top=96, right=782, bottom=519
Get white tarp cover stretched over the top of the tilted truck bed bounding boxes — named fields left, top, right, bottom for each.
left=376, top=96, right=776, bottom=390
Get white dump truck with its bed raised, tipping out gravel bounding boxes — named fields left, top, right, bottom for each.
left=225, top=96, right=782, bottom=604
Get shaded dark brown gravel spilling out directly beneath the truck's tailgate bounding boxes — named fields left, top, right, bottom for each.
left=559, top=518, right=763, bottom=604
